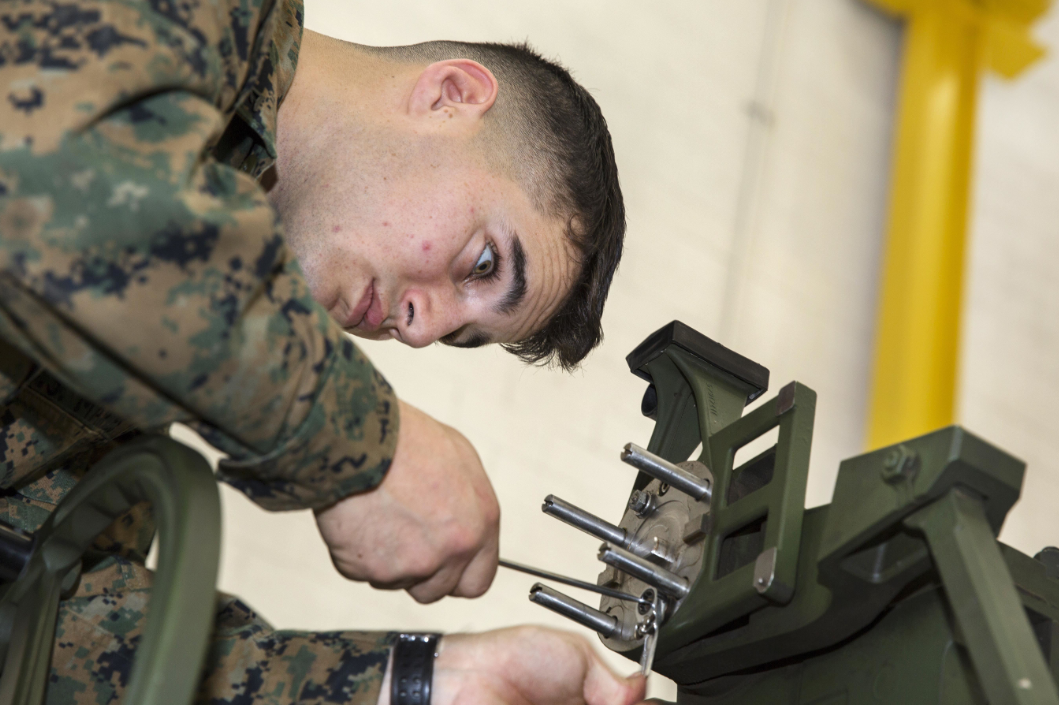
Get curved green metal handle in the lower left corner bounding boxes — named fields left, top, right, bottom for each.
left=0, top=436, right=220, bottom=705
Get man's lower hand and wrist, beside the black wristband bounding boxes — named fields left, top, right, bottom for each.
left=378, top=627, right=647, bottom=705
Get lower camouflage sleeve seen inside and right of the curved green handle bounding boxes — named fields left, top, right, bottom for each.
left=48, top=559, right=394, bottom=705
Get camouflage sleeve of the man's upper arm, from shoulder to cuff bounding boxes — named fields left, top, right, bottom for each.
left=0, top=24, right=398, bottom=509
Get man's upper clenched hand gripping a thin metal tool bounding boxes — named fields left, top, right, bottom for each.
left=317, top=401, right=500, bottom=602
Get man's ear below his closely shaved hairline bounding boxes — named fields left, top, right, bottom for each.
left=408, top=59, right=500, bottom=119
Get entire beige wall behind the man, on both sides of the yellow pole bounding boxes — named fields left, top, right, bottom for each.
left=169, top=0, right=1059, bottom=697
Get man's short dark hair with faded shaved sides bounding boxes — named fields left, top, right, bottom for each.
left=363, top=41, right=625, bottom=369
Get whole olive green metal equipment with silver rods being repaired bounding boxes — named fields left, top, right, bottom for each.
left=531, top=321, right=1059, bottom=705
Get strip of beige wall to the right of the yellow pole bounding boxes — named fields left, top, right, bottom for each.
left=959, top=6, right=1059, bottom=555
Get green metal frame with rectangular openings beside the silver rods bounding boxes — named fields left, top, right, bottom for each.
left=630, top=334, right=816, bottom=659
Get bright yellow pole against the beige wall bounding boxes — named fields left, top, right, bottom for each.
left=867, top=0, right=1051, bottom=448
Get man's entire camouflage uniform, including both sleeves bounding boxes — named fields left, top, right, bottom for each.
left=0, top=0, right=398, bottom=705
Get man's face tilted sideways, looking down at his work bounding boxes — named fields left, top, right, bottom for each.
left=273, top=146, right=576, bottom=347
